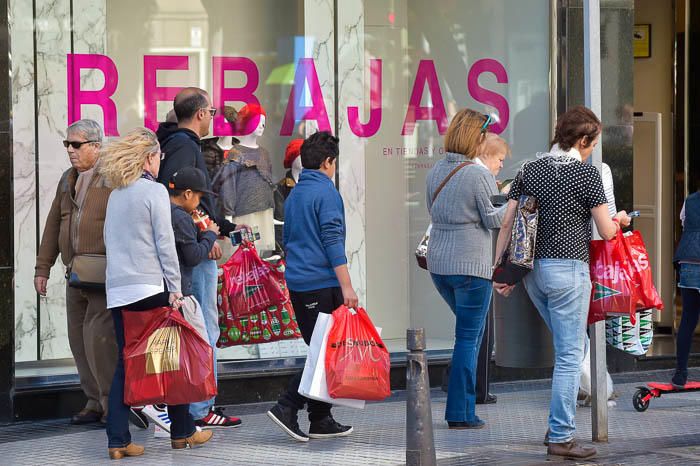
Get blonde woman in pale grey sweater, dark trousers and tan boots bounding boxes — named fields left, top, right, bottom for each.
left=101, top=128, right=212, bottom=459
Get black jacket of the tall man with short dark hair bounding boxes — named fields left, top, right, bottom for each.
left=156, top=123, right=236, bottom=236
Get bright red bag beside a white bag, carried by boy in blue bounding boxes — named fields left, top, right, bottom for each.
left=326, top=306, right=391, bottom=400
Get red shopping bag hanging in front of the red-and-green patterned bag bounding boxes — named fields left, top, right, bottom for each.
left=222, top=241, right=286, bottom=317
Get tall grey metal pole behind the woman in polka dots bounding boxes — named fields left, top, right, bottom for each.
left=583, top=0, right=608, bottom=442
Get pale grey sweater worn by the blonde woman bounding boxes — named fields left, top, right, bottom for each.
left=104, top=178, right=180, bottom=293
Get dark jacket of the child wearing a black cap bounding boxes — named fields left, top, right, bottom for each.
left=170, top=203, right=216, bottom=296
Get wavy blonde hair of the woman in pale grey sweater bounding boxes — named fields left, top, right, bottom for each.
left=100, top=127, right=160, bottom=189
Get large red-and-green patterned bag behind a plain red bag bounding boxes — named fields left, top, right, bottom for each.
left=216, top=259, right=301, bottom=348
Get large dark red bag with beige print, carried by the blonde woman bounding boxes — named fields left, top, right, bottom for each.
left=122, top=307, right=216, bottom=406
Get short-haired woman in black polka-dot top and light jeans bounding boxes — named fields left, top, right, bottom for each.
left=494, top=106, right=630, bottom=459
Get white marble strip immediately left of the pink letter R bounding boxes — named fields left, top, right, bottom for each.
left=36, top=0, right=71, bottom=359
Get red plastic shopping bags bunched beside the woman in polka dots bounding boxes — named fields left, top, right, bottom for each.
left=588, top=231, right=663, bottom=325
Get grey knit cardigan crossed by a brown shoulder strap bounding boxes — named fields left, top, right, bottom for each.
left=426, top=152, right=505, bottom=280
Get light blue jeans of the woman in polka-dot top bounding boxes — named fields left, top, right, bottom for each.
left=524, top=259, right=591, bottom=443
